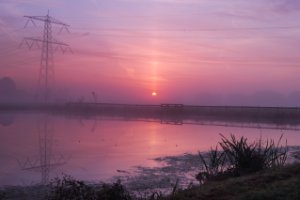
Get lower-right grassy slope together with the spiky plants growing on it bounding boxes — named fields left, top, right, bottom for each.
left=165, top=135, right=300, bottom=200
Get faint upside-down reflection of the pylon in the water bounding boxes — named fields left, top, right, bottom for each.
left=21, top=119, right=66, bottom=184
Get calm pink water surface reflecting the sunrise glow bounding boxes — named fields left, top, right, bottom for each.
left=0, top=113, right=300, bottom=186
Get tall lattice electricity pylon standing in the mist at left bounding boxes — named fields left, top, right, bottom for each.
left=21, top=11, right=72, bottom=103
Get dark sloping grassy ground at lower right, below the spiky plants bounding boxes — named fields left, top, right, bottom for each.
left=168, top=164, right=300, bottom=200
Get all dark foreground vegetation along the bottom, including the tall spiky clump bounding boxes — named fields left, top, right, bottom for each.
left=0, top=135, right=300, bottom=200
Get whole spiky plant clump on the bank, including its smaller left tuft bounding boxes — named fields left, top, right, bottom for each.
left=196, top=134, right=288, bottom=183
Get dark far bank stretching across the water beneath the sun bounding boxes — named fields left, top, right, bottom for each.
left=0, top=102, right=300, bottom=126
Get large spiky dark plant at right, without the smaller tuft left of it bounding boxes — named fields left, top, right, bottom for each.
left=219, top=134, right=287, bottom=175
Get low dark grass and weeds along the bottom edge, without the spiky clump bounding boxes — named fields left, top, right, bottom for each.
left=44, top=164, right=300, bottom=200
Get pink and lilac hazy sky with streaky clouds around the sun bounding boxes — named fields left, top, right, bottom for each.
left=0, top=0, right=300, bottom=106
